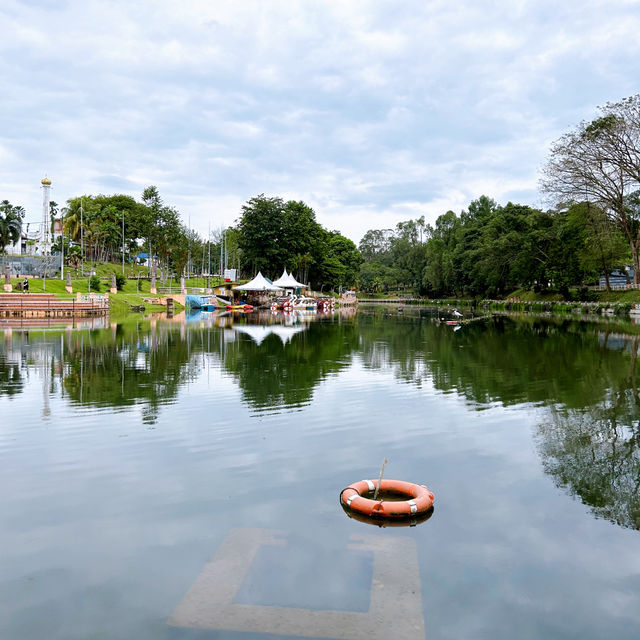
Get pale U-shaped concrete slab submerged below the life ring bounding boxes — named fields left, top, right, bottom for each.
left=168, top=529, right=425, bottom=640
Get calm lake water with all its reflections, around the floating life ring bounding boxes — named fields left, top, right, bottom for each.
left=0, top=307, right=640, bottom=640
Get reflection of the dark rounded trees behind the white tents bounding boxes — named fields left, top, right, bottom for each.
left=223, top=322, right=358, bottom=408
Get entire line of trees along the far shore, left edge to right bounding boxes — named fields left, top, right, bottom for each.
left=0, top=95, right=640, bottom=297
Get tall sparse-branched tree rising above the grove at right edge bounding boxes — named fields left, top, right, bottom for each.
left=541, top=94, right=640, bottom=284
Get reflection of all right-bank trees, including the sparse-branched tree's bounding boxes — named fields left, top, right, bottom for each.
left=359, top=314, right=640, bottom=529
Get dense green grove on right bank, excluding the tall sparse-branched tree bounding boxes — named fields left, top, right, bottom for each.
left=359, top=196, right=629, bottom=298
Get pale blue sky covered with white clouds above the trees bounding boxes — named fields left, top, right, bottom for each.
left=0, top=0, right=640, bottom=242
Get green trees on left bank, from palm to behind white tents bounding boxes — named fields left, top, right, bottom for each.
left=0, top=186, right=362, bottom=291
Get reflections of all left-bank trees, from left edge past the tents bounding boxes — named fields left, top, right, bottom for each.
left=6, top=322, right=358, bottom=423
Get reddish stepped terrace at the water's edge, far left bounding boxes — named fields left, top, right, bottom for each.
left=0, top=293, right=109, bottom=320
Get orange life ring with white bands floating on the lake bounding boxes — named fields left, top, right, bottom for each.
left=340, top=480, right=433, bottom=518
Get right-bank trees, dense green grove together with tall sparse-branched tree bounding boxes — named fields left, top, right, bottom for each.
left=359, top=95, right=640, bottom=297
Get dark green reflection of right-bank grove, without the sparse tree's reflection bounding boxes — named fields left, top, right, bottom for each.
left=359, top=314, right=628, bottom=407
